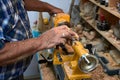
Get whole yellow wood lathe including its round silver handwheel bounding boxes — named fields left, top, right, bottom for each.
left=53, top=13, right=98, bottom=80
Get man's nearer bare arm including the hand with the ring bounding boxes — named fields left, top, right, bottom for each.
left=0, top=26, right=76, bottom=66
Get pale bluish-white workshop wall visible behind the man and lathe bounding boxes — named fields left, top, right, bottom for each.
left=24, top=0, right=79, bottom=76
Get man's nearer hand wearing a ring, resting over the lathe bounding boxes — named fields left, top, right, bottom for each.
left=38, top=25, right=77, bottom=49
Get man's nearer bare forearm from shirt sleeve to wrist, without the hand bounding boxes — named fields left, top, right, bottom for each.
left=0, top=39, right=43, bottom=65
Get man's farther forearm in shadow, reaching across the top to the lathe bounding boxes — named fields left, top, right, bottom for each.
left=24, top=0, right=63, bottom=14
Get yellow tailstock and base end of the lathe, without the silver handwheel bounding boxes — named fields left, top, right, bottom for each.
left=63, top=41, right=91, bottom=80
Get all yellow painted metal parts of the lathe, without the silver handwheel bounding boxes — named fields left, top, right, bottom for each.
left=53, top=13, right=91, bottom=80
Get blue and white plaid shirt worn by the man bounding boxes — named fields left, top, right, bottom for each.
left=0, top=0, right=32, bottom=80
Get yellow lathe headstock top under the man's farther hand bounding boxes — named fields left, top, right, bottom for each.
left=53, top=13, right=70, bottom=27
